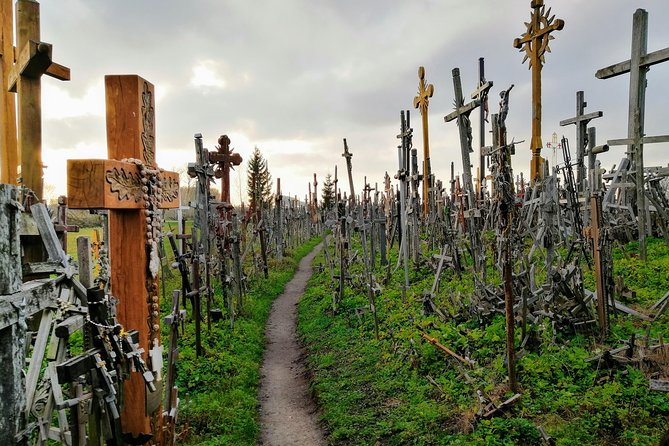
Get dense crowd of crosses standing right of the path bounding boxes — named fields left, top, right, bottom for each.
left=319, top=0, right=669, bottom=398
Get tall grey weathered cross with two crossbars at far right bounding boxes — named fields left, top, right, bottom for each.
left=595, top=9, right=669, bottom=260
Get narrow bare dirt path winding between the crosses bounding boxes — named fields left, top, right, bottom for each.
left=260, top=245, right=325, bottom=446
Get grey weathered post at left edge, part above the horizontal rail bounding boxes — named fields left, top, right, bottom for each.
left=0, top=184, right=22, bottom=295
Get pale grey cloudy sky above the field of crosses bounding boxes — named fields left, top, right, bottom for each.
left=41, top=0, right=669, bottom=203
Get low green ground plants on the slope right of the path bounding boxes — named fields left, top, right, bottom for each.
left=298, top=235, right=669, bottom=445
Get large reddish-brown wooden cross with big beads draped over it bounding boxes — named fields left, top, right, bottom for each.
left=67, top=75, right=179, bottom=436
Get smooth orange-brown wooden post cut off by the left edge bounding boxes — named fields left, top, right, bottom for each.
left=0, top=0, right=20, bottom=185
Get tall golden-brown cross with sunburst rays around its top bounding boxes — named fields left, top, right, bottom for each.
left=513, top=0, right=564, bottom=184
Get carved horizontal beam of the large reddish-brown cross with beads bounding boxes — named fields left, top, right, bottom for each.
left=67, top=159, right=179, bottom=209
